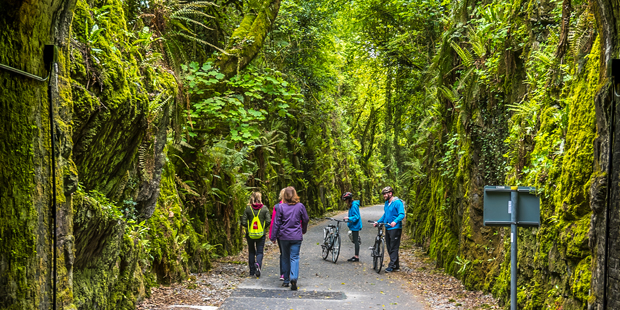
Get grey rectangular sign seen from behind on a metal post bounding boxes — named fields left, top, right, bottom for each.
left=483, top=186, right=540, bottom=310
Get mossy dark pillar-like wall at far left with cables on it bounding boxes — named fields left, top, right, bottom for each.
left=0, top=0, right=75, bottom=309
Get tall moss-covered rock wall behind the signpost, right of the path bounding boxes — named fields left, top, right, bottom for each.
left=408, top=2, right=618, bottom=309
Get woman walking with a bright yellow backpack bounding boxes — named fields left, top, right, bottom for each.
left=241, top=192, right=271, bottom=277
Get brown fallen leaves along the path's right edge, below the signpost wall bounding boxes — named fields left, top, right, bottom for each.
left=392, top=237, right=500, bottom=310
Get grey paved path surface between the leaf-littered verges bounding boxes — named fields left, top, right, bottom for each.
left=220, top=206, right=425, bottom=310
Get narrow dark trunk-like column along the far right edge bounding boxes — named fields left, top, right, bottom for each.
left=588, top=0, right=620, bottom=310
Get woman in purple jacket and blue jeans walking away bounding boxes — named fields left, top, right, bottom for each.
left=270, top=186, right=309, bottom=291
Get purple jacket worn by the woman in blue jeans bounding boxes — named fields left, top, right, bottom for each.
left=271, top=202, right=309, bottom=241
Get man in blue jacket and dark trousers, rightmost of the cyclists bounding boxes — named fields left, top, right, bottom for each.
left=374, top=186, right=405, bottom=272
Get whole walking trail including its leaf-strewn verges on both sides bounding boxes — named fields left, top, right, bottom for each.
left=137, top=206, right=500, bottom=310
